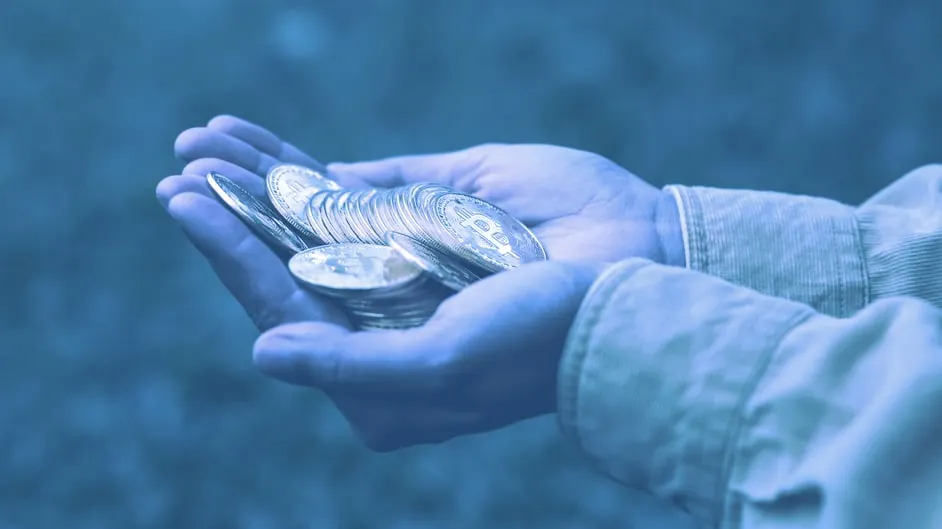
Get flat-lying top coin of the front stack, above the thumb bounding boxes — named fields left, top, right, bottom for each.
left=288, top=243, right=422, bottom=292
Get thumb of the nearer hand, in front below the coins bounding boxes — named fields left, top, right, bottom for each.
left=254, top=322, right=449, bottom=400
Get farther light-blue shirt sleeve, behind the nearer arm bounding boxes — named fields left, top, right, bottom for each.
left=666, top=165, right=942, bottom=317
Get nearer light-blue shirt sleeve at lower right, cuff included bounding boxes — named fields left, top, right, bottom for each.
left=558, top=260, right=942, bottom=529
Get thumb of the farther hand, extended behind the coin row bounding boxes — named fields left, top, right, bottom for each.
left=327, top=145, right=501, bottom=189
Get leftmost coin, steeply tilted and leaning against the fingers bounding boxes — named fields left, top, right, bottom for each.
left=206, top=172, right=308, bottom=253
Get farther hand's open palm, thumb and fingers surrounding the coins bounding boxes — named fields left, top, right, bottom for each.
left=157, top=116, right=659, bottom=330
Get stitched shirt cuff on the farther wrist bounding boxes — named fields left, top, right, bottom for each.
left=666, top=186, right=869, bottom=317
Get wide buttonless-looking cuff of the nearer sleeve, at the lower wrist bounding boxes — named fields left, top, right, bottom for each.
left=558, top=259, right=813, bottom=525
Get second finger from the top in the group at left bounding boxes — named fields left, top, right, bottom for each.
left=173, top=127, right=278, bottom=177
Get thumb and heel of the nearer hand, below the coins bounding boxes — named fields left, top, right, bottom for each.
left=255, top=261, right=601, bottom=451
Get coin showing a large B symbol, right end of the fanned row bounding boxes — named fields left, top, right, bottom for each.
left=433, top=192, right=546, bottom=272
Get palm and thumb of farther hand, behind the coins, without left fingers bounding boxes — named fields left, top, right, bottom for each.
left=329, top=140, right=673, bottom=262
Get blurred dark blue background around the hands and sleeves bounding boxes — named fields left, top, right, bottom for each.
left=0, top=0, right=942, bottom=529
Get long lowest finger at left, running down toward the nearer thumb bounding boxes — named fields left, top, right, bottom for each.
left=167, top=192, right=346, bottom=331
